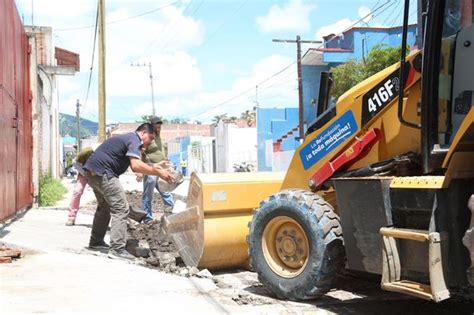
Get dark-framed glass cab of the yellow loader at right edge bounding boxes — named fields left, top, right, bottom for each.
left=420, top=0, right=474, bottom=174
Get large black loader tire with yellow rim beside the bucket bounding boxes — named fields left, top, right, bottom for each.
left=247, top=189, right=345, bottom=301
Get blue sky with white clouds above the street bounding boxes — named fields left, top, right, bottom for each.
left=16, top=0, right=416, bottom=123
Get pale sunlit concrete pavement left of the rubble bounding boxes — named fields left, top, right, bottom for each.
left=0, top=176, right=235, bottom=314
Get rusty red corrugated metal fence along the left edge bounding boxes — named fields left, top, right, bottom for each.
left=0, top=0, right=33, bottom=222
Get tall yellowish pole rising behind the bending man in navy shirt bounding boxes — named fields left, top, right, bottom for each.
left=98, top=0, right=106, bottom=142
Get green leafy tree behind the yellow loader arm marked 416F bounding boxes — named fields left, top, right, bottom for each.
left=331, top=44, right=409, bottom=99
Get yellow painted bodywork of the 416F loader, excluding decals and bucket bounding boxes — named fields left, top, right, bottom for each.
left=282, top=51, right=421, bottom=189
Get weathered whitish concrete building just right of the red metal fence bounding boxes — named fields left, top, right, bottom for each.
left=25, top=26, right=80, bottom=202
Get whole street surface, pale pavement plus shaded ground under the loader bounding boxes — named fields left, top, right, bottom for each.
left=0, top=176, right=474, bottom=314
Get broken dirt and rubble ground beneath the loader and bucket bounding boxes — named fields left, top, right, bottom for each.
left=86, top=191, right=474, bottom=315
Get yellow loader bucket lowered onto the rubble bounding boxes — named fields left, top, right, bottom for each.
left=165, top=172, right=285, bottom=270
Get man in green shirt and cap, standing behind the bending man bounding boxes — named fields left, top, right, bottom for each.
left=142, top=116, right=174, bottom=222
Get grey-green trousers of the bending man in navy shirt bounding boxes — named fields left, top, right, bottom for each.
left=87, top=175, right=129, bottom=251
